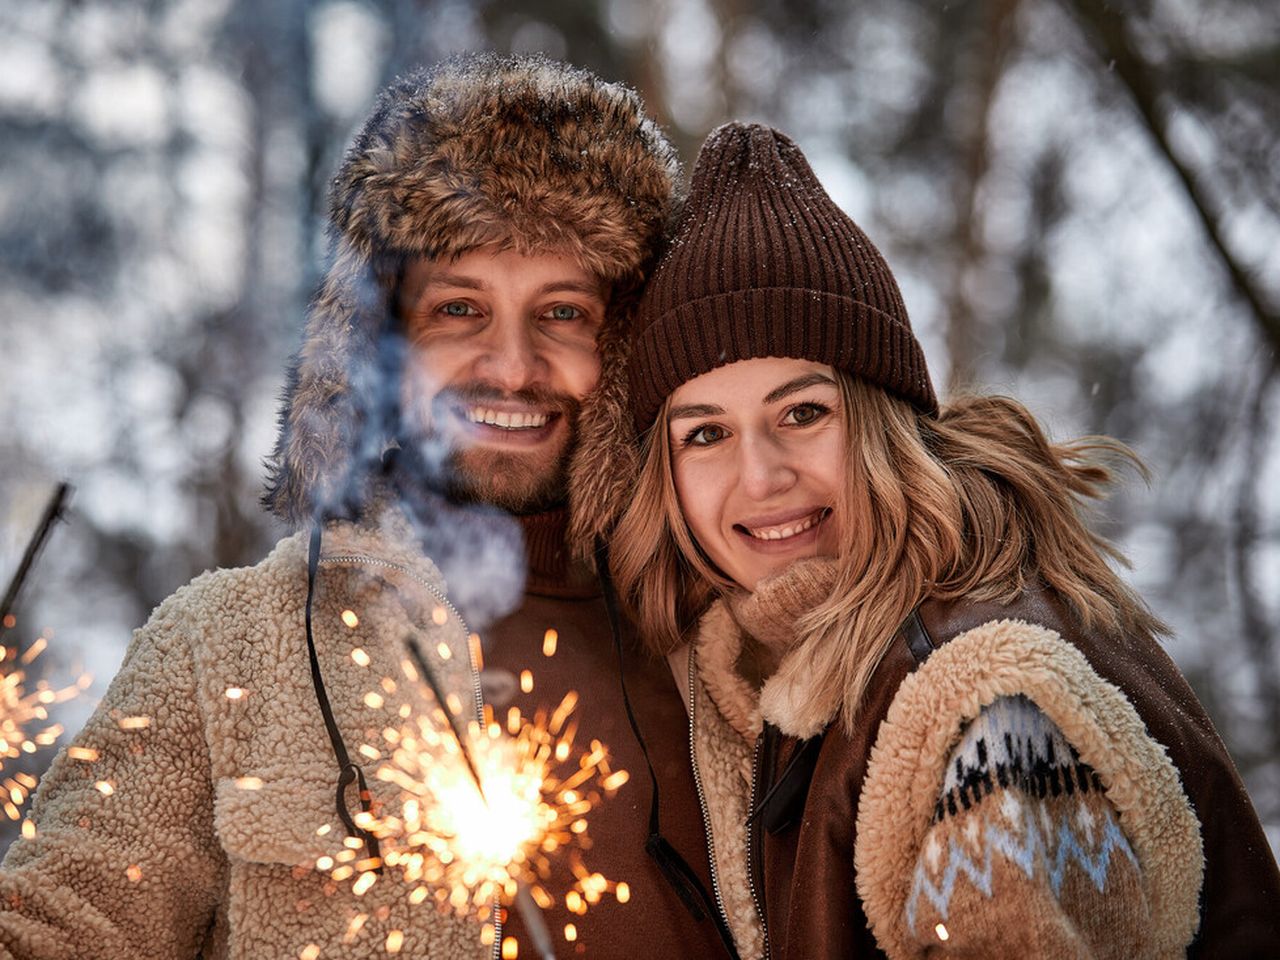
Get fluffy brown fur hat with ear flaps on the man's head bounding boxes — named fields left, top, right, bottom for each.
left=264, top=55, right=678, bottom=525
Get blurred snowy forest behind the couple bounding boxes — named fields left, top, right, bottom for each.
left=0, top=0, right=1280, bottom=847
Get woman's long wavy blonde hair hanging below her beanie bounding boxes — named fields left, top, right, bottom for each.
left=611, top=371, right=1167, bottom=728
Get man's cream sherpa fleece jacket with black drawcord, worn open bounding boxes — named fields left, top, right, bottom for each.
left=0, top=524, right=492, bottom=960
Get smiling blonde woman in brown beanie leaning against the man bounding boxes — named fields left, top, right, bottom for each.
left=576, top=124, right=1280, bottom=957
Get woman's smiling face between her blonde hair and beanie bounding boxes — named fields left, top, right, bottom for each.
left=668, top=357, right=847, bottom=590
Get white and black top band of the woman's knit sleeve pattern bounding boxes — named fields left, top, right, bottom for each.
left=933, top=696, right=1101, bottom=822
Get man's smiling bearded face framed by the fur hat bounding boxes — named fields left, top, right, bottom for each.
left=399, top=247, right=608, bottom=513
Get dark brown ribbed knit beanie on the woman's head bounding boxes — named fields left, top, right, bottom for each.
left=630, top=123, right=938, bottom=431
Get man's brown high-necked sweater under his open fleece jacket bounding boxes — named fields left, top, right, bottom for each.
left=481, top=512, right=723, bottom=960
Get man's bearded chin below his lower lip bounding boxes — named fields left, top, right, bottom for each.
left=448, top=444, right=568, bottom=515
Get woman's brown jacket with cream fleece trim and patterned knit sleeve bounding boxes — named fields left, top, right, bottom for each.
left=687, top=590, right=1280, bottom=960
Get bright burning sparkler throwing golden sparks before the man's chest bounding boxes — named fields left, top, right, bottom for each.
left=327, top=632, right=630, bottom=956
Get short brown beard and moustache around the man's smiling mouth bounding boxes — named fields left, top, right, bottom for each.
left=401, top=383, right=581, bottom=515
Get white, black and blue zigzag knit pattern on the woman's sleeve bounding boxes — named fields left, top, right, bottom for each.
left=906, top=696, right=1138, bottom=933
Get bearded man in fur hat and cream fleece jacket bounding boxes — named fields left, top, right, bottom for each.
left=0, top=58, right=719, bottom=960
